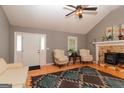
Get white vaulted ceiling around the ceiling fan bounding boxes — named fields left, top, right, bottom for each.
left=2, top=5, right=119, bottom=34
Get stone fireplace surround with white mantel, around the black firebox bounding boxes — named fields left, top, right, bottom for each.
left=93, top=40, right=124, bottom=64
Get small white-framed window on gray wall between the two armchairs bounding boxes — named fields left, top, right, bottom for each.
left=68, top=36, right=77, bottom=50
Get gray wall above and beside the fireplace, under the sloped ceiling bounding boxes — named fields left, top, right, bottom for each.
left=86, top=6, right=124, bottom=56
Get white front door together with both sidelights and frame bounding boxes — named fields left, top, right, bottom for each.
left=15, top=32, right=46, bottom=66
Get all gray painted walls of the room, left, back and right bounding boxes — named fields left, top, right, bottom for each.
left=0, top=6, right=124, bottom=63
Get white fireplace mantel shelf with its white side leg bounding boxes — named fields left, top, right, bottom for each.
left=93, top=40, right=124, bottom=64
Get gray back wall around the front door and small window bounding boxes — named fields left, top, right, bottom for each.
left=10, top=26, right=85, bottom=63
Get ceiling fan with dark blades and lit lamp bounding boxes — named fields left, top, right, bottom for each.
left=65, top=5, right=97, bottom=18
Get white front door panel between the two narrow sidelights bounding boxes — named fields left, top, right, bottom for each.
left=22, top=33, right=40, bottom=66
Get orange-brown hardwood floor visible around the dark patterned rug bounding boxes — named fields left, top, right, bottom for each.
left=26, top=63, right=124, bottom=88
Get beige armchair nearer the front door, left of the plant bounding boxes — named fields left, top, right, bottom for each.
left=54, top=49, right=68, bottom=66
